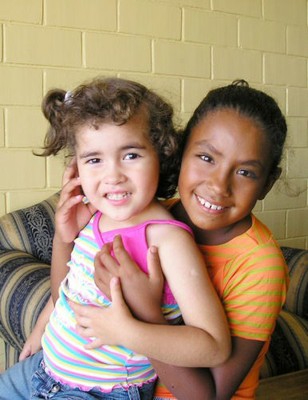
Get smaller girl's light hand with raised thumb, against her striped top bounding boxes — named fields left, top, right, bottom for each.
left=70, top=278, right=136, bottom=349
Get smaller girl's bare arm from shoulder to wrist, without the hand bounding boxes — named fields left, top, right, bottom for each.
left=119, top=227, right=230, bottom=367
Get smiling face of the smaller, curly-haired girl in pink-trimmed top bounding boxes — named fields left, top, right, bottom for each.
left=76, top=115, right=159, bottom=225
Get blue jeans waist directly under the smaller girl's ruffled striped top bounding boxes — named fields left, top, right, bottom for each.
left=31, top=367, right=155, bottom=400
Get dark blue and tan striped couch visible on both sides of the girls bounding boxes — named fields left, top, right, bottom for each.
left=0, top=193, right=308, bottom=378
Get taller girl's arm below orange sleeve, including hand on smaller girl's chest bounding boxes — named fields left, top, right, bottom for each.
left=95, top=240, right=264, bottom=400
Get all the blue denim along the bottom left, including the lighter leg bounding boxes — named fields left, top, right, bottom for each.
left=0, top=352, right=155, bottom=400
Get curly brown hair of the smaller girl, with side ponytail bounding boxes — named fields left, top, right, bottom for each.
left=40, top=78, right=180, bottom=198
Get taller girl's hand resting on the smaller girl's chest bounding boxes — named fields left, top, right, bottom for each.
left=94, top=236, right=165, bottom=322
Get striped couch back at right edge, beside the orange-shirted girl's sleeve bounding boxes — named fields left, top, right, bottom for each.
left=282, top=247, right=308, bottom=320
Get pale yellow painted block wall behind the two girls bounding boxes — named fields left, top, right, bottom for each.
left=0, top=0, right=308, bottom=247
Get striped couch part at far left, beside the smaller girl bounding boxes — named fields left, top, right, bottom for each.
left=0, top=193, right=59, bottom=367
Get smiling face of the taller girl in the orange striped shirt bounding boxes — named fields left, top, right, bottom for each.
left=179, top=109, right=274, bottom=244
